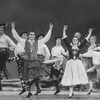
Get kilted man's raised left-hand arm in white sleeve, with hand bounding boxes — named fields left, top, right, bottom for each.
left=11, top=22, right=23, bottom=43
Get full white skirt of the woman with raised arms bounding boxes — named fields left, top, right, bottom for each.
left=61, top=59, right=88, bottom=86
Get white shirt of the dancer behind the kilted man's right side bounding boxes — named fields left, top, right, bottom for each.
left=37, top=44, right=50, bottom=61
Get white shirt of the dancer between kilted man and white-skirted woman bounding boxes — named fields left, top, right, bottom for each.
left=51, top=45, right=65, bottom=57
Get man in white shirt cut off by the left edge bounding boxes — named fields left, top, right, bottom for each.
left=0, top=24, right=16, bottom=91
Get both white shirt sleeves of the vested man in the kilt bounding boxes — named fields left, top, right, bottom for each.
left=12, top=28, right=52, bottom=52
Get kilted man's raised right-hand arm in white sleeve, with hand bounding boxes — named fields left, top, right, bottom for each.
left=38, top=23, right=53, bottom=47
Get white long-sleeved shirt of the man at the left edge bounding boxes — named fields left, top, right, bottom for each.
left=0, top=34, right=16, bottom=51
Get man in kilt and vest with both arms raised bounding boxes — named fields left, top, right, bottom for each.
left=11, top=22, right=53, bottom=98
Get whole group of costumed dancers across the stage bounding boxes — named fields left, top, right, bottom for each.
left=0, top=22, right=100, bottom=98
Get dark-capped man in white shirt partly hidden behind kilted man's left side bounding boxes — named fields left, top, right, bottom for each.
left=9, top=31, right=28, bottom=95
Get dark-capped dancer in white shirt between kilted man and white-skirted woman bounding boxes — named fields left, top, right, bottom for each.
left=50, top=37, right=65, bottom=95
